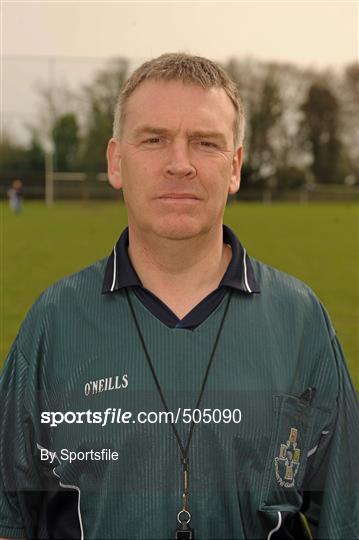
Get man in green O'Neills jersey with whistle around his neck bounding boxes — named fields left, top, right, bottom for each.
left=0, top=54, right=359, bottom=540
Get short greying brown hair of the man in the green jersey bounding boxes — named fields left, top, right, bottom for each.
left=113, top=53, right=245, bottom=148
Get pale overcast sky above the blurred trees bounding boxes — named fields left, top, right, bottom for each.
left=1, top=0, right=359, bottom=143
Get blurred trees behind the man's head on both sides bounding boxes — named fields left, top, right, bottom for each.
left=0, top=59, right=359, bottom=189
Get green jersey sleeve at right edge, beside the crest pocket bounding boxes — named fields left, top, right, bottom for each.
left=304, top=334, right=359, bottom=540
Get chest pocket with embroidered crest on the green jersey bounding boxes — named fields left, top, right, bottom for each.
left=260, top=395, right=313, bottom=512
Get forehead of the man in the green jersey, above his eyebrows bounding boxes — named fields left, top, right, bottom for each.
left=124, top=80, right=235, bottom=134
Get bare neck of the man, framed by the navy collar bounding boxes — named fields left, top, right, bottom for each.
left=128, top=226, right=232, bottom=318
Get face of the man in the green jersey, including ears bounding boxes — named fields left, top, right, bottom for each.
left=107, top=80, right=242, bottom=240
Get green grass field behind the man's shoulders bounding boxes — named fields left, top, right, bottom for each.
left=0, top=199, right=359, bottom=388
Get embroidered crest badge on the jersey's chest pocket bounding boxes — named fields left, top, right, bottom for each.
left=274, top=428, right=300, bottom=488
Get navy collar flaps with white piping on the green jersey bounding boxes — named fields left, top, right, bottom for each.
left=102, top=225, right=260, bottom=294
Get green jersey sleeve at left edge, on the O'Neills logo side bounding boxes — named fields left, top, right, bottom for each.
left=0, top=340, right=29, bottom=538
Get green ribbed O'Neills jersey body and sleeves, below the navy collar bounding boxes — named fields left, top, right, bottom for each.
left=0, top=251, right=359, bottom=540
